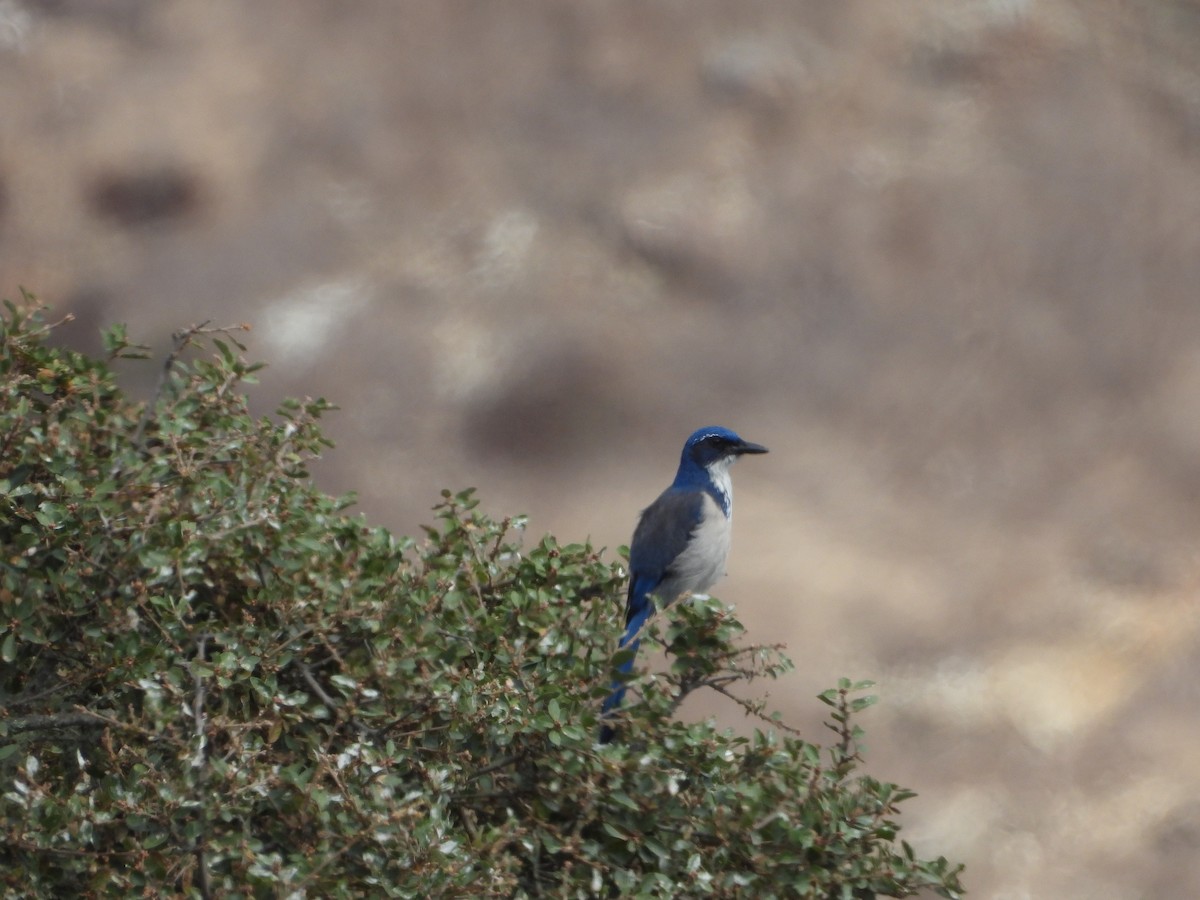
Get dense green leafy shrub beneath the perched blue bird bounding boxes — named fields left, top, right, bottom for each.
left=0, top=304, right=961, bottom=898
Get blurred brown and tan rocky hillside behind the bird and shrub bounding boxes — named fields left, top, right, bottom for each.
left=0, top=0, right=1200, bottom=900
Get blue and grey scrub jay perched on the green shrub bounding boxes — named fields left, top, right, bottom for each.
left=600, top=425, right=767, bottom=744
